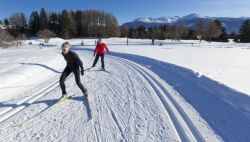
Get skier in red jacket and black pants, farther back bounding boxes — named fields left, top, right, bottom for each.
left=92, top=39, right=109, bottom=70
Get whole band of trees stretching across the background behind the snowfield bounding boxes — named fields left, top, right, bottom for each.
left=0, top=8, right=250, bottom=42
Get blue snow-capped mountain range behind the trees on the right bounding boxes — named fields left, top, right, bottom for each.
left=122, top=14, right=250, bottom=33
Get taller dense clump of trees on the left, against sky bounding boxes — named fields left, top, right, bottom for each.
left=2, top=8, right=119, bottom=39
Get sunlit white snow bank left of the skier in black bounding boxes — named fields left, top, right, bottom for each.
left=0, top=46, right=65, bottom=101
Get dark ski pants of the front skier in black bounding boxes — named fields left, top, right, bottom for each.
left=60, top=66, right=87, bottom=94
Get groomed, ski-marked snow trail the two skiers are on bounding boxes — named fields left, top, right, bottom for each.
left=0, top=51, right=219, bottom=142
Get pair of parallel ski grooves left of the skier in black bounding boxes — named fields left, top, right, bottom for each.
left=0, top=74, right=72, bottom=123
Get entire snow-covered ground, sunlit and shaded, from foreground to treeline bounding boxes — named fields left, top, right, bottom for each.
left=0, top=38, right=250, bottom=142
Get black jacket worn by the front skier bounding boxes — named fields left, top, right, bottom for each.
left=62, top=50, right=83, bottom=71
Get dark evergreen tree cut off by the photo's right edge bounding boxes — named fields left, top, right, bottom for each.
left=239, top=20, right=250, bottom=43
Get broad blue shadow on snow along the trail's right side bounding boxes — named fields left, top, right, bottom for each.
left=74, top=48, right=250, bottom=142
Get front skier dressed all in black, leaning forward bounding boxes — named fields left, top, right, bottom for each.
left=60, top=42, right=87, bottom=98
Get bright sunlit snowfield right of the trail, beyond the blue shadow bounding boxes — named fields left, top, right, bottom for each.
left=99, top=39, right=250, bottom=95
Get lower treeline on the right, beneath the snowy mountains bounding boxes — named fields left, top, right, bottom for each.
left=120, top=20, right=250, bottom=42
